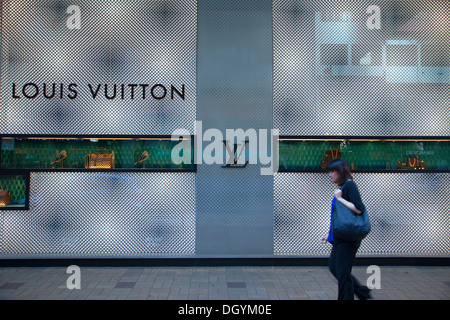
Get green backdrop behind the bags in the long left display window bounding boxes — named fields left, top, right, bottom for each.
left=2, top=138, right=194, bottom=170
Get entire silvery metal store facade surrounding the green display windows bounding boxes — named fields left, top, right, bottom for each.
left=0, top=0, right=450, bottom=258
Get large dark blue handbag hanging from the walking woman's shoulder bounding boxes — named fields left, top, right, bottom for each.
left=331, top=196, right=371, bottom=241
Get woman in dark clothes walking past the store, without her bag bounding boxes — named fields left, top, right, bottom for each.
left=322, top=158, right=371, bottom=300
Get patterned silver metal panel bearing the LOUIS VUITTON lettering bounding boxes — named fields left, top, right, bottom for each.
left=0, top=0, right=197, bottom=135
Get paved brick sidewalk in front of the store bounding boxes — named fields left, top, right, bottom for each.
left=0, top=266, right=450, bottom=300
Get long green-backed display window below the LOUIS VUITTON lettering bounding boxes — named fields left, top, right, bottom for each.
left=0, top=135, right=196, bottom=172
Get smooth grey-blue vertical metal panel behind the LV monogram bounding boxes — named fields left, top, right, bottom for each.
left=196, top=0, right=273, bottom=257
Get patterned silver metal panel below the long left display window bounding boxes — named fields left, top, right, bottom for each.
left=0, top=173, right=195, bottom=258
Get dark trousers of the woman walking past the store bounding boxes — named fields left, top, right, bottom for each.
left=329, top=236, right=370, bottom=300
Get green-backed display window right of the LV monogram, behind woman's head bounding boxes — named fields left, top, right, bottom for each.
left=278, top=136, right=450, bottom=173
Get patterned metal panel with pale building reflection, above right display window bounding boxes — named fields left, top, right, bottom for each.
left=273, top=0, right=450, bottom=136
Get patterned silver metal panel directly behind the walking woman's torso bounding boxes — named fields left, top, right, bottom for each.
left=274, top=173, right=450, bottom=257
